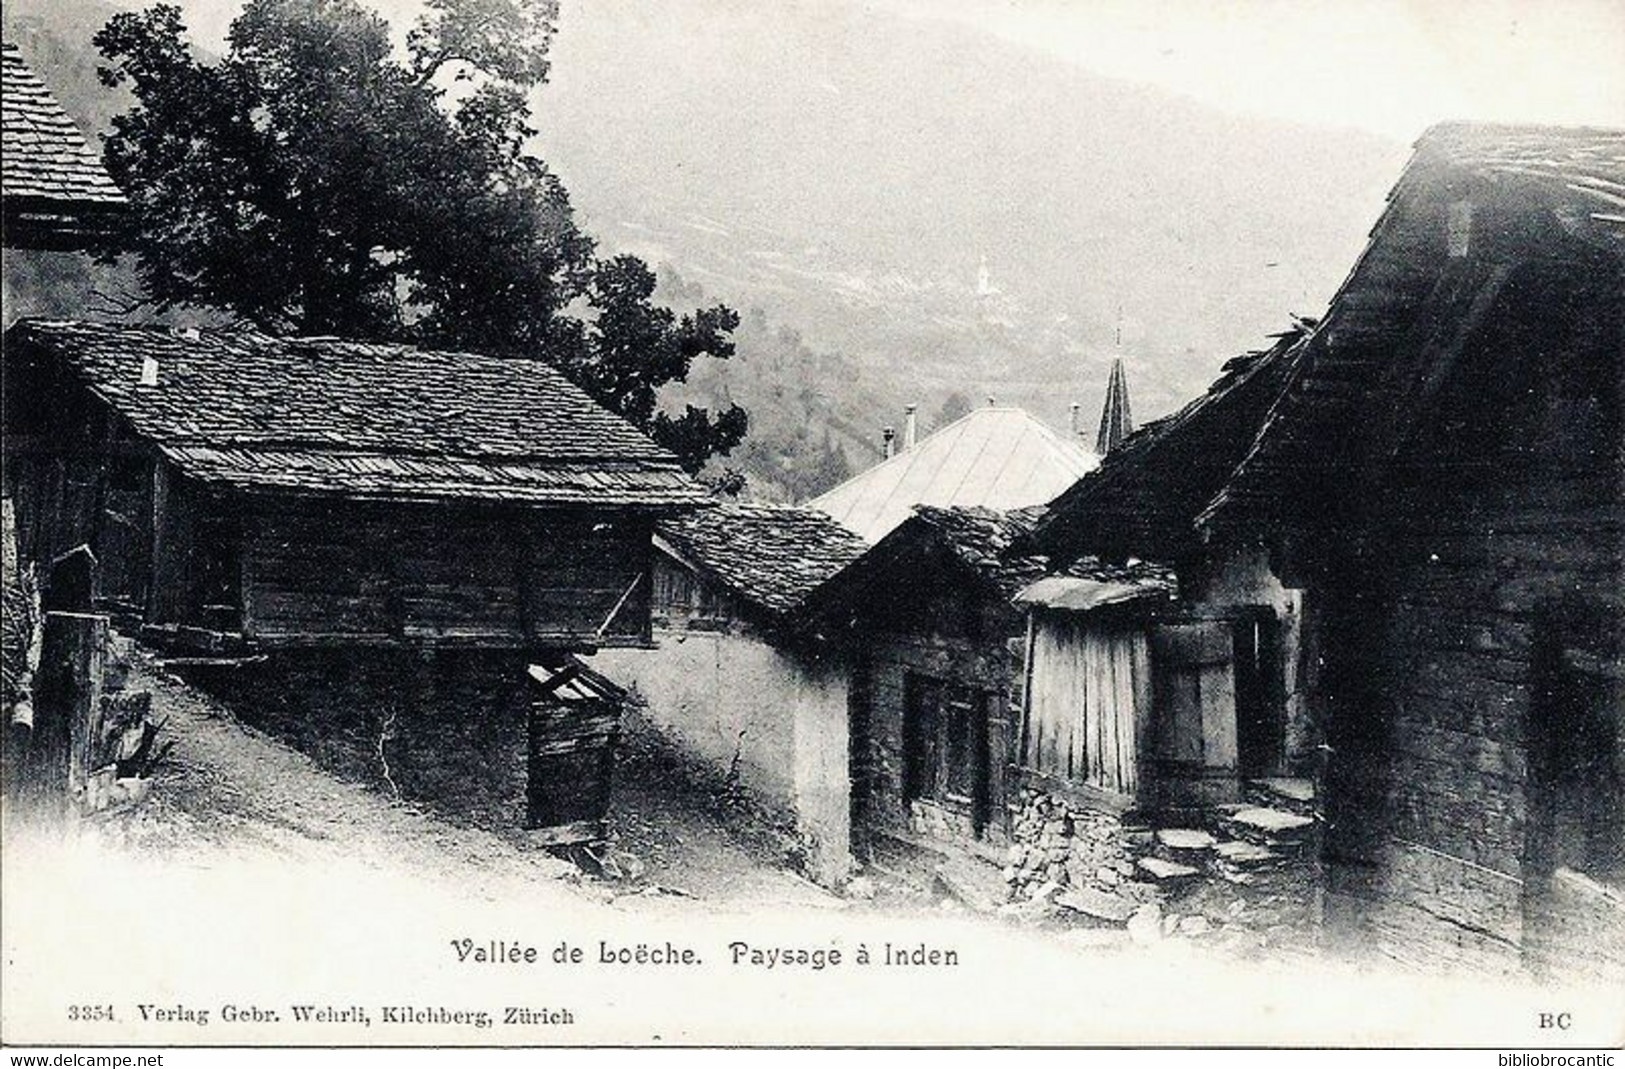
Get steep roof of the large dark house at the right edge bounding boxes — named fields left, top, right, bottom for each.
left=1199, top=123, right=1625, bottom=533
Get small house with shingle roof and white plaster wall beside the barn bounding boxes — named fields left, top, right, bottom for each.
left=592, top=502, right=865, bottom=884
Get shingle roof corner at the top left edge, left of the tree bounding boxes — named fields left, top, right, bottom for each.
left=0, top=42, right=125, bottom=249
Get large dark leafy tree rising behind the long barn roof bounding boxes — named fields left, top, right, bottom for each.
left=96, top=0, right=746, bottom=471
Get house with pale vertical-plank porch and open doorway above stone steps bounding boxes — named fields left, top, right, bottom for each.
left=1016, top=330, right=1316, bottom=811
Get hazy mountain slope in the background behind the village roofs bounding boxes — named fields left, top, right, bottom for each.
left=5, top=0, right=1406, bottom=496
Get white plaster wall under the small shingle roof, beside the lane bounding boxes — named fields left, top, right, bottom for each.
left=590, top=630, right=852, bottom=884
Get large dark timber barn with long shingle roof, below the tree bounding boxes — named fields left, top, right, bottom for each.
left=5, top=320, right=709, bottom=651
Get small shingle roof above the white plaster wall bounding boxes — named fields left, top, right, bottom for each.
left=657, top=502, right=868, bottom=612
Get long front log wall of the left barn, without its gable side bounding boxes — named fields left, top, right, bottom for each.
left=239, top=499, right=650, bottom=647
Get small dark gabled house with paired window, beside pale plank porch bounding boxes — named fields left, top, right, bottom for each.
left=801, top=505, right=1043, bottom=853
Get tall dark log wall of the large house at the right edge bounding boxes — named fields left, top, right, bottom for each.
left=1308, top=242, right=1625, bottom=975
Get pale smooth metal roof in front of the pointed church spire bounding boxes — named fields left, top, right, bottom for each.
left=808, top=406, right=1099, bottom=543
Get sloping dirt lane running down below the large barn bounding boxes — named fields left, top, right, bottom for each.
left=104, top=650, right=842, bottom=908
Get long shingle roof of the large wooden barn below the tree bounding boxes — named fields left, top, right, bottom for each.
left=5, top=320, right=710, bottom=507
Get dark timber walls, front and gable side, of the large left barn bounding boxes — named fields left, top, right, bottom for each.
left=5, top=354, right=653, bottom=648
